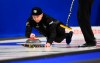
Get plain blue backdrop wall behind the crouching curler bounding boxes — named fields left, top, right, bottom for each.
left=0, top=0, right=100, bottom=38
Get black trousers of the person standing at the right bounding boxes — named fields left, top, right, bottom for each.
left=77, top=0, right=95, bottom=44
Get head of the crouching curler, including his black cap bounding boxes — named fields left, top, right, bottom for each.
left=32, top=7, right=43, bottom=23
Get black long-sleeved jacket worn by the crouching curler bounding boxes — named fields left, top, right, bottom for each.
left=25, top=14, right=65, bottom=43
